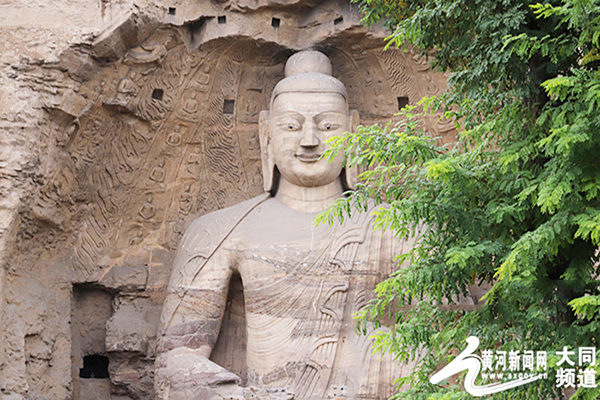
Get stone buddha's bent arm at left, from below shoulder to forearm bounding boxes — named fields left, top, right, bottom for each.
left=154, top=251, right=244, bottom=400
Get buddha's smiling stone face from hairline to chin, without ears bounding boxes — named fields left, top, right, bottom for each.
left=269, top=92, right=349, bottom=187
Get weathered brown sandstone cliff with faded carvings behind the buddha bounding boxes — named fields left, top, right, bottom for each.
left=0, top=0, right=453, bottom=400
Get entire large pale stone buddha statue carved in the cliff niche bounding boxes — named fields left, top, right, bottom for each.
left=155, top=51, right=406, bottom=400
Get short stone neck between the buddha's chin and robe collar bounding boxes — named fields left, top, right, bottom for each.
left=275, top=176, right=344, bottom=213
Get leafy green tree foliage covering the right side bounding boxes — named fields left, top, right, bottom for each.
left=320, top=0, right=600, bottom=399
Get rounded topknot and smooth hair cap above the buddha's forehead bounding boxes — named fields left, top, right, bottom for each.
left=271, top=50, right=348, bottom=105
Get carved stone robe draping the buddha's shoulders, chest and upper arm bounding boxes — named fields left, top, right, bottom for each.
left=159, top=198, right=414, bottom=400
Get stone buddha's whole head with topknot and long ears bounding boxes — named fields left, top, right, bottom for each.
left=259, top=51, right=358, bottom=192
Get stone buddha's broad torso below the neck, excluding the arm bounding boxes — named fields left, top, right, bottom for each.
left=220, top=199, right=393, bottom=399
